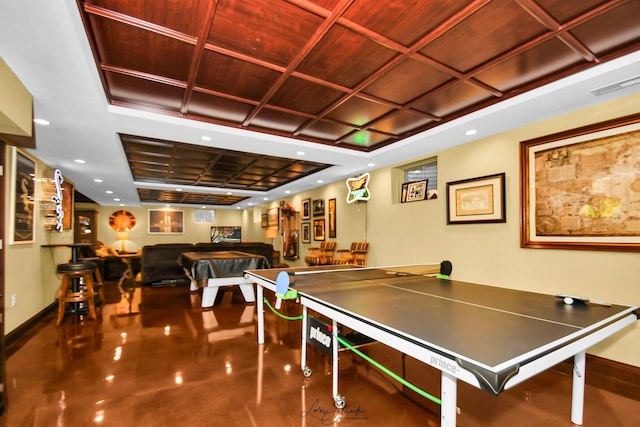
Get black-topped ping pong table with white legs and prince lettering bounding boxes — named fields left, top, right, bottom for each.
left=245, top=266, right=638, bottom=426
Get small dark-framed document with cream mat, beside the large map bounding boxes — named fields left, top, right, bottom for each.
left=447, top=173, right=507, bottom=224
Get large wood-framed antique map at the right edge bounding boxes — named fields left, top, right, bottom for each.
left=520, top=114, right=640, bottom=252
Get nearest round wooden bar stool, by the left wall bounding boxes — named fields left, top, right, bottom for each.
left=56, top=261, right=97, bottom=325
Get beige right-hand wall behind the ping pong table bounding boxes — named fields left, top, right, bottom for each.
left=249, top=94, right=640, bottom=367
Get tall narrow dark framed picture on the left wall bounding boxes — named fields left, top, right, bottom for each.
left=9, top=147, right=36, bottom=244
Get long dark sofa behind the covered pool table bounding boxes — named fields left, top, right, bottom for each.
left=141, top=242, right=273, bottom=286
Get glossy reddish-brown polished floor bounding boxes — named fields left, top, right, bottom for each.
left=0, top=283, right=640, bottom=427
